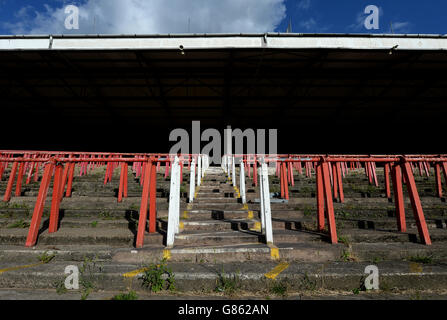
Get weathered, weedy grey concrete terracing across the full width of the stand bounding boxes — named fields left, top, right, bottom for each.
left=0, top=162, right=447, bottom=300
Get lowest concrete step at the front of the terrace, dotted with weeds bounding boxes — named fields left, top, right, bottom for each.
left=0, top=261, right=447, bottom=294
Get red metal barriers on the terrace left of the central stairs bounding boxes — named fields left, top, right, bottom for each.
left=0, top=151, right=205, bottom=248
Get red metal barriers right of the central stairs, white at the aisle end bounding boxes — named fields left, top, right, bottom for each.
left=229, top=155, right=447, bottom=245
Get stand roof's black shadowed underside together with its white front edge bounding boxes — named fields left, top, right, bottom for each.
left=0, top=36, right=447, bottom=153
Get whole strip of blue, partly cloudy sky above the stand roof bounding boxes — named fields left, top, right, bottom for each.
left=0, top=0, right=447, bottom=34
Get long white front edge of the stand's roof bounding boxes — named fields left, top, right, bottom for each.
left=0, top=33, right=447, bottom=50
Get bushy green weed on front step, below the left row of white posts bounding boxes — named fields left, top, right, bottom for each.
left=141, top=259, right=175, bottom=292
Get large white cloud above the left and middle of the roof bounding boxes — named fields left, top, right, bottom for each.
left=4, top=0, right=286, bottom=34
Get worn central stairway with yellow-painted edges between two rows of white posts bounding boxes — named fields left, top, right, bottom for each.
left=158, top=167, right=271, bottom=262
